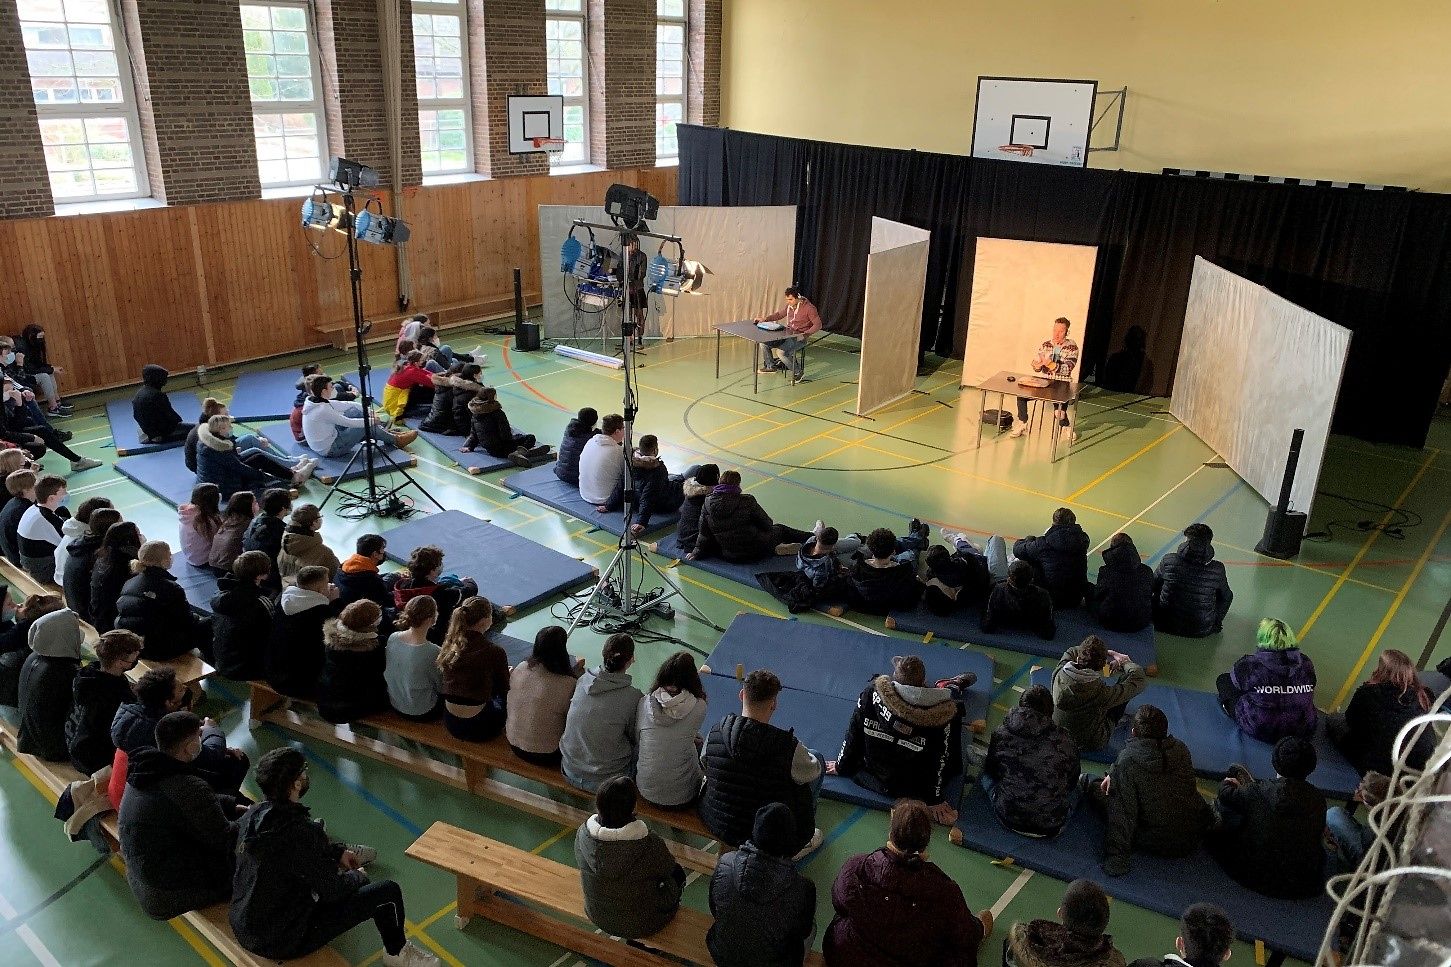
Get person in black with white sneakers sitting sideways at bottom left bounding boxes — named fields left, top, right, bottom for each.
left=228, top=745, right=438, bottom=967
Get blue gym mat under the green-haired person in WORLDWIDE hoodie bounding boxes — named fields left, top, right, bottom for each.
left=1029, top=668, right=1360, bottom=799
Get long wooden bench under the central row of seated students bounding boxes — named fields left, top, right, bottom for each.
left=250, top=682, right=717, bottom=873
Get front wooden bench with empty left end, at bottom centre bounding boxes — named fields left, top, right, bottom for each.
left=403, top=822, right=824, bottom=967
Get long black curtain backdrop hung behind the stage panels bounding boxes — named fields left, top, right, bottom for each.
left=679, top=125, right=1451, bottom=447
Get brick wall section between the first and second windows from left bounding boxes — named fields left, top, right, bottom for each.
left=122, top=0, right=260, bottom=205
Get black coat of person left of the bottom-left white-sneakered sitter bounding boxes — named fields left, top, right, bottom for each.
left=119, top=748, right=237, bottom=921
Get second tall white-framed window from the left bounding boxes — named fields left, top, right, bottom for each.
left=242, top=3, right=326, bottom=187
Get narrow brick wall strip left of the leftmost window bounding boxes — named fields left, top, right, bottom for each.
left=0, top=3, right=55, bottom=218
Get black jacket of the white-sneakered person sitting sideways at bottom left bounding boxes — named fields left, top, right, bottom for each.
left=228, top=801, right=367, bottom=960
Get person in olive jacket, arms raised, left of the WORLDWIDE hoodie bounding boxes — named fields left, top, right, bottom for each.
left=1053, top=635, right=1149, bottom=752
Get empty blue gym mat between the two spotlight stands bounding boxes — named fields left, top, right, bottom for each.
left=383, top=510, right=596, bottom=610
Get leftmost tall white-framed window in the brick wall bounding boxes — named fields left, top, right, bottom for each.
left=16, top=0, right=151, bottom=203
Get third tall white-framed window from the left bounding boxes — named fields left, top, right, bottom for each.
left=414, top=0, right=473, bottom=174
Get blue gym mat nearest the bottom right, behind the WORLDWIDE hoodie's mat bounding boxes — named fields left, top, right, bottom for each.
left=958, top=786, right=1333, bottom=961
